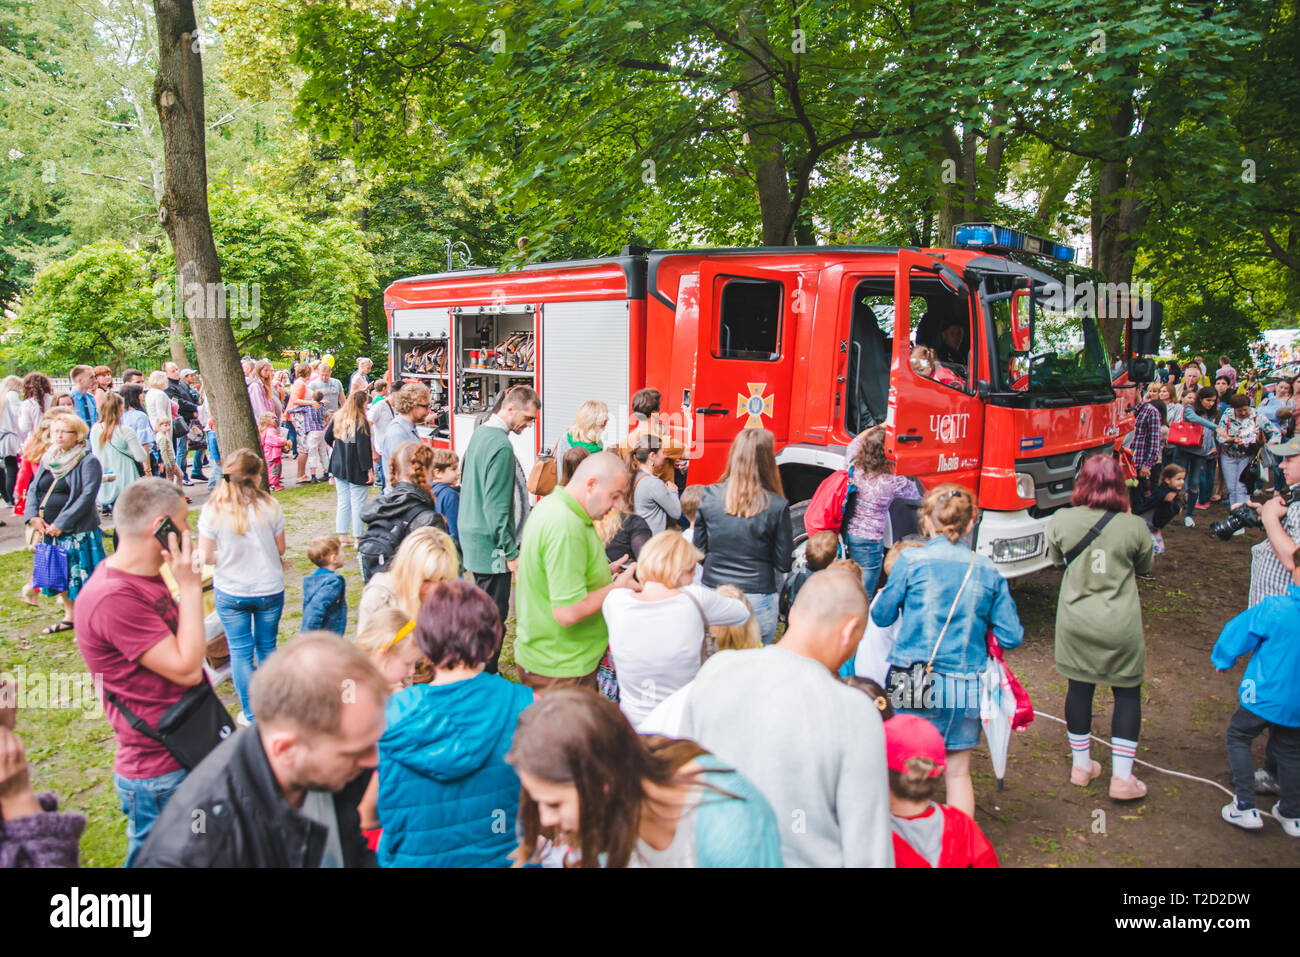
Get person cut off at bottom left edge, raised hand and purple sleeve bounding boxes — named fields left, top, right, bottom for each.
left=0, top=679, right=86, bottom=870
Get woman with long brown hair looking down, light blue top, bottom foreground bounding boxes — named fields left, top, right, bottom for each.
left=506, top=688, right=781, bottom=867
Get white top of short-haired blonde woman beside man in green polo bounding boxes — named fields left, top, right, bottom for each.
left=602, top=585, right=749, bottom=727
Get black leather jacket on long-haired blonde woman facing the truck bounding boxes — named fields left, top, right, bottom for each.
left=696, top=484, right=794, bottom=594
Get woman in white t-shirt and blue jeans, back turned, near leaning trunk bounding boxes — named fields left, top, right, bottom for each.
left=199, top=449, right=285, bottom=724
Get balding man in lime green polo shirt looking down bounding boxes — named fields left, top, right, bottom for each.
left=515, top=452, right=641, bottom=692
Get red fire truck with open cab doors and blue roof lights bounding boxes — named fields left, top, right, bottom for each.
left=384, top=224, right=1158, bottom=576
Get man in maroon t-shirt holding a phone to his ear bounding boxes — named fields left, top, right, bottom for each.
left=75, top=479, right=207, bottom=867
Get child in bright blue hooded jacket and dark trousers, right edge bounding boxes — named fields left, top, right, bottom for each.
left=1210, top=549, right=1300, bottom=837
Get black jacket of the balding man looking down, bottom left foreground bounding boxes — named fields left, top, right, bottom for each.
left=135, top=727, right=377, bottom=867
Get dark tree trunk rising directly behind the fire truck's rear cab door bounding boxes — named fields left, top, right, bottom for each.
left=732, top=13, right=794, bottom=246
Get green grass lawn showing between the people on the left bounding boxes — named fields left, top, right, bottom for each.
left=0, top=485, right=516, bottom=867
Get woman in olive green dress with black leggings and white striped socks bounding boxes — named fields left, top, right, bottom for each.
left=1048, top=455, right=1154, bottom=801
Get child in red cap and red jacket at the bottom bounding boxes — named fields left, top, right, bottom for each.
left=885, top=714, right=997, bottom=867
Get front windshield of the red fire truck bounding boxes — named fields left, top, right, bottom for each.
left=980, top=274, right=1113, bottom=402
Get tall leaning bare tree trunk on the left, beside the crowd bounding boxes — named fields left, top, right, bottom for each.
left=153, top=0, right=265, bottom=468
